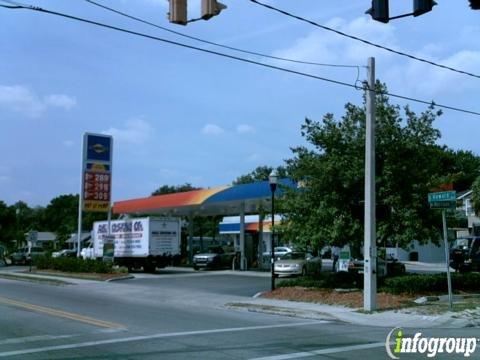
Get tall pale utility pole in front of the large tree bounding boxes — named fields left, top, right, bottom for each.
left=363, top=57, right=377, bottom=311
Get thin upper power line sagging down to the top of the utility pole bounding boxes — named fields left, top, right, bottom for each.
left=85, top=0, right=361, bottom=70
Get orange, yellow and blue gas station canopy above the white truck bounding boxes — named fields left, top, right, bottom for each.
left=113, top=179, right=296, bottom=216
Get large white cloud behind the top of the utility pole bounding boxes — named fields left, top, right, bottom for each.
left=272, top=17, right=480, bottom=102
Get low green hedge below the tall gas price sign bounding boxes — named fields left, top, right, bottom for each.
left=34, top=256, right=114, bottom=274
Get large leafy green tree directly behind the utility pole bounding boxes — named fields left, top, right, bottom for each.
left=281, top=83, right=454, bottom=253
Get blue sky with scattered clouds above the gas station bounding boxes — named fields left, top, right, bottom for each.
left=0, top=0, right=480, bottom=206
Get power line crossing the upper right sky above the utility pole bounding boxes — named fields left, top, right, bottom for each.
left=250, top=0, right=480, bottom=79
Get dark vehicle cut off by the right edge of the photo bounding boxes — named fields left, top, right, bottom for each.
left=450, top=236, right=480, bottom=272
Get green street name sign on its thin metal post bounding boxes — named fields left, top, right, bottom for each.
left=428, top=191, right=457, bottom=310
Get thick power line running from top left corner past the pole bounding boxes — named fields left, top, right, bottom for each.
left=0, top=0, right=480, bottom=116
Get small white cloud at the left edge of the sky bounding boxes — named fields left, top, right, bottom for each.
left=0, top=85, right=76, bottom=118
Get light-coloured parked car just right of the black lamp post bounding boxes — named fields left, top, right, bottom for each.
left=274, top=252, right=322, bottom=276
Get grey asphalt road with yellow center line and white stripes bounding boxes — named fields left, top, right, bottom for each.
left=0, top=272, right=477, bottom=360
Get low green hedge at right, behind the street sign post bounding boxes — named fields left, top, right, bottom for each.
left=383, top=273, right=480, bottom=294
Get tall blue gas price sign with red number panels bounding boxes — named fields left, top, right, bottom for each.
left=81, top=133, right=113, bottom=212
